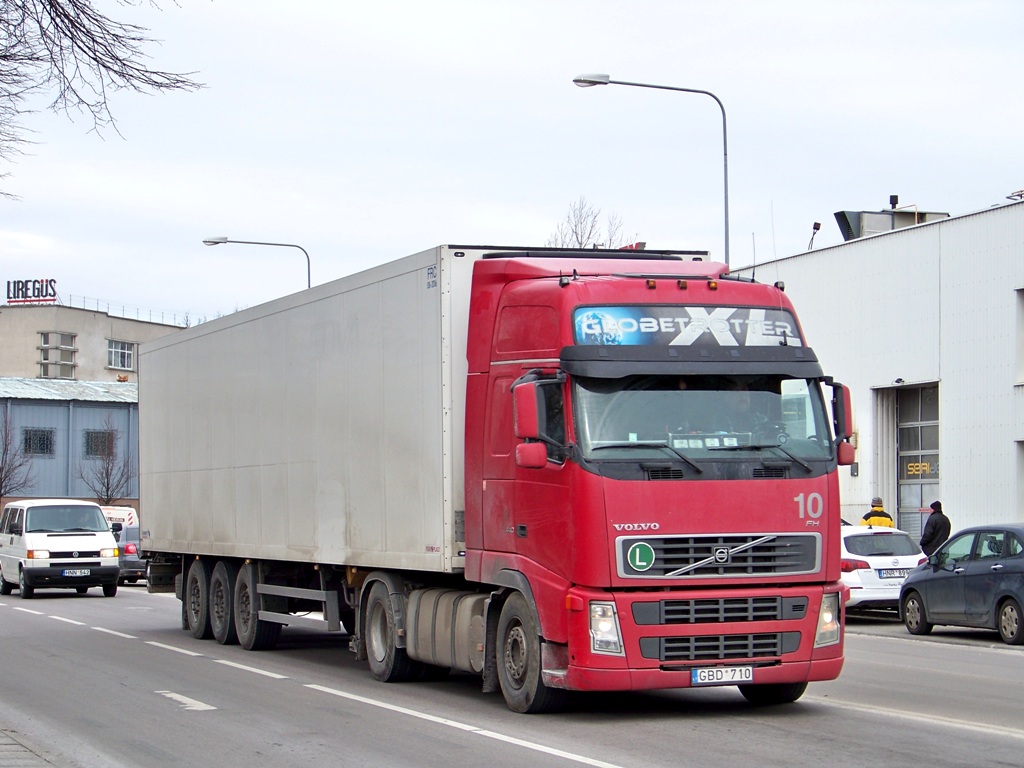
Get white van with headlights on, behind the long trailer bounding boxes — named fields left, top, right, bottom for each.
left=0, top=499, right=121, bottom=598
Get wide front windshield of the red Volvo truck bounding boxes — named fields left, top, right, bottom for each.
left=573, top=376, right=831, bottom=462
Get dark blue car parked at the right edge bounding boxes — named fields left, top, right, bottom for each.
left=899, top=525, right=1024, bottom=645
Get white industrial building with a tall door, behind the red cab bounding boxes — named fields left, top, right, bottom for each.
left=738, top=202, right=1024, bottom=532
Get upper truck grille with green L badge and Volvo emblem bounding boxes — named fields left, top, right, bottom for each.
left=615, top=534, right=821, bottom=580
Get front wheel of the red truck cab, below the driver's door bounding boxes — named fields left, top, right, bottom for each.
left=496, top=592, right=565, bottom=714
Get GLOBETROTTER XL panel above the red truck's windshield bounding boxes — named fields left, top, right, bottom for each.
left=574, top=305, right=801, bottom=347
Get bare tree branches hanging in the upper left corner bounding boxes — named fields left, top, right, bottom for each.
left=0, top=0, right=201, bottom=189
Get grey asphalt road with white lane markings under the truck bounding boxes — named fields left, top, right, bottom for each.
left=0, top=586, right=1024, bottom=768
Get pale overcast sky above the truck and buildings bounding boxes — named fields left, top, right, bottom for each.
left=0, top=0, right=1024, bottom=321
